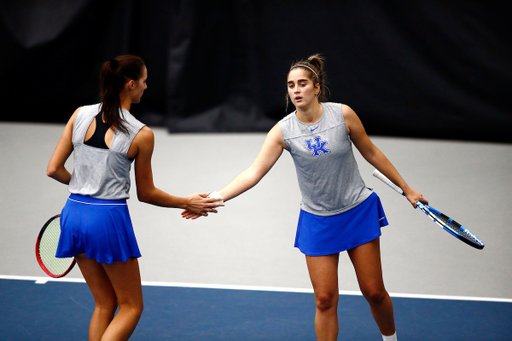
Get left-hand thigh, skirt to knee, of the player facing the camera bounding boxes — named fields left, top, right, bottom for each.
left=306, top=253, right=340, bottom=294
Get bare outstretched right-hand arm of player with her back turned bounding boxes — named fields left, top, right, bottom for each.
left=128, top=127, right=219, bottom=215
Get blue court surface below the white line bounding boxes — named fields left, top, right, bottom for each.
left=0, top=279, right=512, bottom=341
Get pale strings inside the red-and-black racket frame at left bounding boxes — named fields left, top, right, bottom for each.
left=38, top=219, right=71, bottom=276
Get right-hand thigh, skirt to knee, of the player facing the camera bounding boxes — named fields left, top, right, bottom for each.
left=347, top=238, right=384, bottom=293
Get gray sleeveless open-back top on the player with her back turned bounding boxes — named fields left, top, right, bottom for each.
left=68, top=104, right=144, bottom=200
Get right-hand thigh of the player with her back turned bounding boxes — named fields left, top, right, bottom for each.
left=102, top=258, right=142, bottom=305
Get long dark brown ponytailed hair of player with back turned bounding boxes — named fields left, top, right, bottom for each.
left=100, top=55, right=145, bottom=133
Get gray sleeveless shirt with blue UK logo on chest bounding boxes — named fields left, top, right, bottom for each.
left=278, top=103, right=372, bottom=216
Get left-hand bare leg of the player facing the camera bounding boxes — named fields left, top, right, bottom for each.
left=306, top=254, right=339, bottom=341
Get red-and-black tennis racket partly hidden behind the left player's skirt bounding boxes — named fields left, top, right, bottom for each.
left=36, top=214, right=76, bottom=278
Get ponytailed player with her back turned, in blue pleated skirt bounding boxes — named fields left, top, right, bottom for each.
left=47, top=55, right=219, bottom=341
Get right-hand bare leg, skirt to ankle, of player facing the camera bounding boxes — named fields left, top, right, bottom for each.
left=348, top=238, right=395, bottom=335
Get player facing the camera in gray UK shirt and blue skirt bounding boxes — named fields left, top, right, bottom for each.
left=182, top=55, right=427, bottom=340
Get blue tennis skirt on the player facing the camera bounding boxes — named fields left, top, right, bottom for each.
left=295, top=193, right=388, bottom=256
